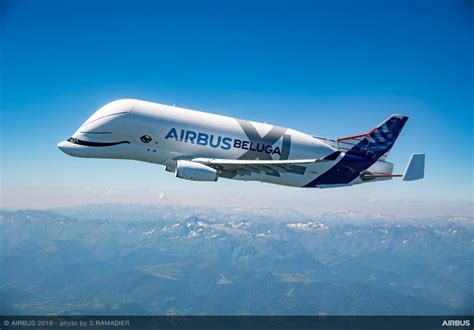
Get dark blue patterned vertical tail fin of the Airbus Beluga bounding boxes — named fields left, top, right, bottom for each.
left=337, top=115, right=408, bottom=159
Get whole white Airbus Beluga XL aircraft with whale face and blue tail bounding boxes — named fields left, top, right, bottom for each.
left=58, top=99, right=425, bottom=188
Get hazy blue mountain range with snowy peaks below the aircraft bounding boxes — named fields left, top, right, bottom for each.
left=0, top=204, right=474, bottom=315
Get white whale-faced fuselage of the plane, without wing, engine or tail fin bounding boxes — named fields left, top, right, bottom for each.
left=58, top=100, right=392, bottom=187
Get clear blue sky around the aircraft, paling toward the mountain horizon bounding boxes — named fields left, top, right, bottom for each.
left=0, top=0, right=474, bottom=216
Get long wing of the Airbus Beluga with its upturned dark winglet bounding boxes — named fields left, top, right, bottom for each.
left=191, top=151, right=341, bottom=176
